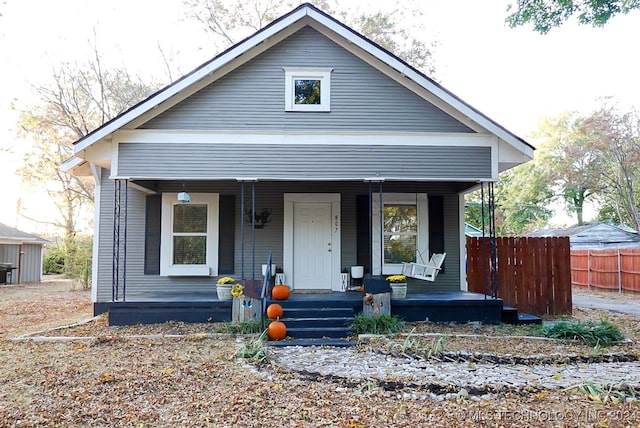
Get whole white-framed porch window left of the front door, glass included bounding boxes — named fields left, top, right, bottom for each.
left=160, top=193, right=219, bottom=276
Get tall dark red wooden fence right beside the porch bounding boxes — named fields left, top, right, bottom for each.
left=467, top=237, right=572, bottom=315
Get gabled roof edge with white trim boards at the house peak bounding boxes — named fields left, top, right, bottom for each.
left=63, top=3, right=534, bottom=170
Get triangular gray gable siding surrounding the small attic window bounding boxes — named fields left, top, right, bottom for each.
left=141, top=27, right=473, bottom=133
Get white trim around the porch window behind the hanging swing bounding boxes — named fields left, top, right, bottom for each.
left=371, top=193, right=429, bottom=275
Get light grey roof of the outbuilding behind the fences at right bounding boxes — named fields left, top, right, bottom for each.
left=527, top=223, right=640, bottom=250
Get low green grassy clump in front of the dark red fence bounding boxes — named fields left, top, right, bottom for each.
left=544, top=319, right=625, bottom=346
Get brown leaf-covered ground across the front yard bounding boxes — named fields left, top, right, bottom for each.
left=0, top=281, right=640, bottom=427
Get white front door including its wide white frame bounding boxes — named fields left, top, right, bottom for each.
left=283, top=193, right=340, bottom=290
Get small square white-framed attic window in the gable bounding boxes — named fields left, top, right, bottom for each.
left=284, top=67, right=333, bottom=112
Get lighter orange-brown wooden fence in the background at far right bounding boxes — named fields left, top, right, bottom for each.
left=571, top=248, right=640, bottom=293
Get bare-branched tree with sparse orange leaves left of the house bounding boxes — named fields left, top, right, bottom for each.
left=18, top=49, right=157, bottom=252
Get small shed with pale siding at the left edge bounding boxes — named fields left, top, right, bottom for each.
left=0, top=223, right=49, bottom=284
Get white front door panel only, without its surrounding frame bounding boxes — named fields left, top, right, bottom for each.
left=293, top=202, right=331, bottom=290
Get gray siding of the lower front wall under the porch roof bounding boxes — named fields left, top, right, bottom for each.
left=96, top=170, right=460, bottom=302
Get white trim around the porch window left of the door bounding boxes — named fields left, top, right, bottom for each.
left=160, top=193, right=220, bottom=276
